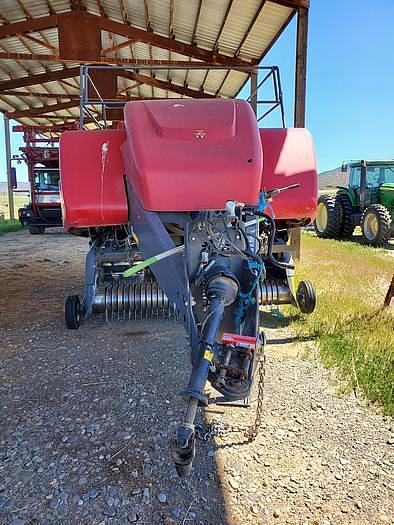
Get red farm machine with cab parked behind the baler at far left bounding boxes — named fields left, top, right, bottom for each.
left=12, top=126, right=73, bottom=235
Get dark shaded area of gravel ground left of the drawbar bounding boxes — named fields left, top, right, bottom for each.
left=0, top=230, right=229, bottom=525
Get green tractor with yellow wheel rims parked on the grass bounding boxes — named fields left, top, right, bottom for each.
left=314, top=160, right=394, bottom=246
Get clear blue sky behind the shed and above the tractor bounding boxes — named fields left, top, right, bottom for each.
left=0, top=0, right=394, bottom=180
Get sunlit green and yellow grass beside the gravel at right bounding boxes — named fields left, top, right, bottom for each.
left=292, top=233, right=394, bottom=415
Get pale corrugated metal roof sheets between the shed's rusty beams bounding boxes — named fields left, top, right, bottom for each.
left=0, top=0, right=294, bottom=124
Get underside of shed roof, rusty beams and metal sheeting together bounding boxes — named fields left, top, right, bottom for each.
left=0, top=0, right=309, bottom=123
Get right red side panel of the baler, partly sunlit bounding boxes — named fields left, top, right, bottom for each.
left=260, top=128, right=317, bottom=220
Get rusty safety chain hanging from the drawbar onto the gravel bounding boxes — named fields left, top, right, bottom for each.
left=195, top=346, right=265, bottom=441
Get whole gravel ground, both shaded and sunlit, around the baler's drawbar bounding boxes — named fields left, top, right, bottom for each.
left=0, top=230, right=394, bottom=525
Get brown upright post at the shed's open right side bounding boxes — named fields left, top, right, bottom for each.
left=294, top=8, right=308, bottom=128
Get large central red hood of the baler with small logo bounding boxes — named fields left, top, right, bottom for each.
left=122, top=100, right=262, bottom=212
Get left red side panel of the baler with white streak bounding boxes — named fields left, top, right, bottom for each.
left=60, top=130, right=128, bottom=231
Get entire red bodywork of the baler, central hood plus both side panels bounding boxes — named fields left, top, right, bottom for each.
left=60, top=100, right=317, bottom=231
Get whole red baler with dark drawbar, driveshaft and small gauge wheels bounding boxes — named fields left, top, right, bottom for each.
left=61, top=96, right=316, bottom=475
